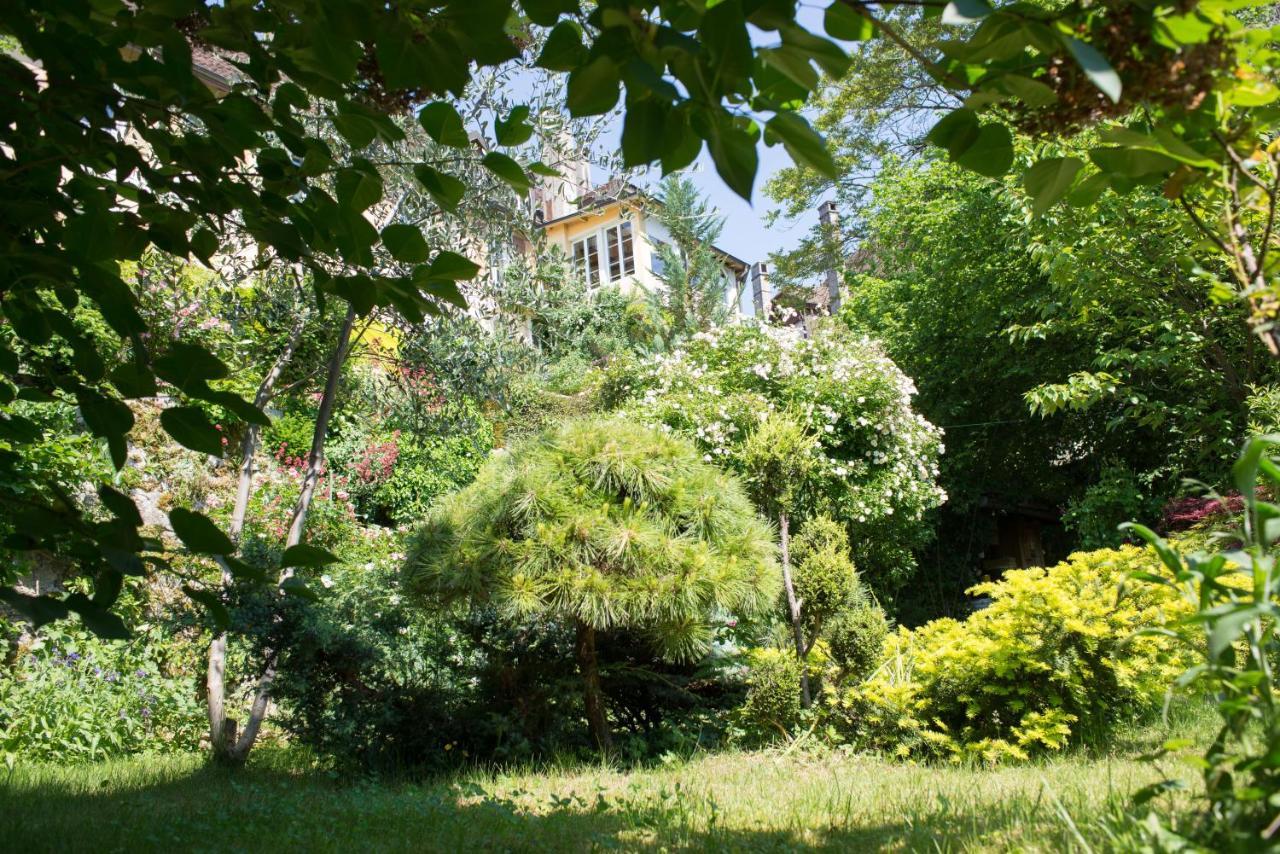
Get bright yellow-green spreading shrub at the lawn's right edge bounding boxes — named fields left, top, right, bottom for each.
left=828, top=547, right=1189, bottom=762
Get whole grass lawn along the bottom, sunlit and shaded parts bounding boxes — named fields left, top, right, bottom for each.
left=0, top=717, right=1210, bottom=851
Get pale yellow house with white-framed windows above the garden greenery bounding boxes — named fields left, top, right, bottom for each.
left=530, top=163, right=772, bottom=318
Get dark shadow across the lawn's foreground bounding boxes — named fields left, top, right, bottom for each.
left=0, top=767, right=1070, bottom=853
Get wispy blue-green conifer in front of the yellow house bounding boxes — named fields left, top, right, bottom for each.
left=653, top=175, right=732, bottom=341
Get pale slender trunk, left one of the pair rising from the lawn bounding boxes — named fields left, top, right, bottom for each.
left=205, top=311, right=307, bottom=761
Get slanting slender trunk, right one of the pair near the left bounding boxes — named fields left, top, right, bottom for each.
left=215, top=307, right=356, bottom=764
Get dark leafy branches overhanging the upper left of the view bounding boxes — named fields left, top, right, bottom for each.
left=0, top=0, right=844, bottom=635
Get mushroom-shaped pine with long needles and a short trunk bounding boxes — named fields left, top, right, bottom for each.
left=404, top=419, right=777, bottom=752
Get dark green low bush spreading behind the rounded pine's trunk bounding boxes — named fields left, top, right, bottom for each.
left=247, top=529, right=740, bottom=772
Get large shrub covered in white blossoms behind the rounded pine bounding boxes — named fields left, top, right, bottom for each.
left=600, top=321, right=946, bottom=589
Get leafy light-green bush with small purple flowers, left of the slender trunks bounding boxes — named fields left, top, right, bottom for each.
left=0, top=624, right=207, bottom=763
